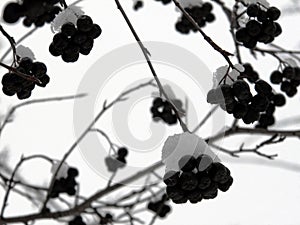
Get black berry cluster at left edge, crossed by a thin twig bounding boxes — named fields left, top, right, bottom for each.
left=2, top=57, right=50, bottom=100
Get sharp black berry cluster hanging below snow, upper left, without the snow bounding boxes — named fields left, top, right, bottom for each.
left=49, top=15, right=102, bottom=63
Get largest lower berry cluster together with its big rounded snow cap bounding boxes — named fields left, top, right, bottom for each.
left=162, top=132, right=233, bottom=204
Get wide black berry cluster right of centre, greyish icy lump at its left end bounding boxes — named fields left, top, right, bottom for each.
left=207, top=64, right=286, bottom=128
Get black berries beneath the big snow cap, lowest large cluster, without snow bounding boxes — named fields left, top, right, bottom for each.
left=163, top=155, right=233, bottom=204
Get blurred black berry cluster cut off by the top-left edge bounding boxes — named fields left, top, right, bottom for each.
left=3, top=0, right=61, bottom=27
